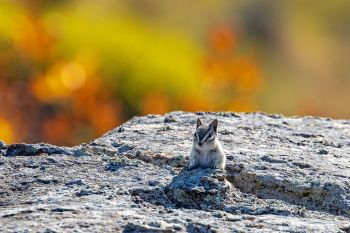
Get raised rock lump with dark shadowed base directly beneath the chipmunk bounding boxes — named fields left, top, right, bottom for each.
left=130, top=169, right=305, bottom=217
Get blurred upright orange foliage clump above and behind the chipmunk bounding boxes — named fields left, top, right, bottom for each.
left=204, top=26, right=263, bottom=111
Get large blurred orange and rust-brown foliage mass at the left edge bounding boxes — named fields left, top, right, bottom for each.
left=0, top=11, right=121, bottom=145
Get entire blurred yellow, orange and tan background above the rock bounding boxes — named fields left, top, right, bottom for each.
left=0, top=0, right=350, bottom=145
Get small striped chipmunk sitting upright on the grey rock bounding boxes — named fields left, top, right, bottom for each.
left=188, top=118, right=226, bottom=169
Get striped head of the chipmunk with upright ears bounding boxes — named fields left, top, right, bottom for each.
left=193, top=118, right=218, bottom=148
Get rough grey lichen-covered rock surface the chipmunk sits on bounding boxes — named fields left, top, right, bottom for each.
left=0, top=112, right=350, bottom=232
